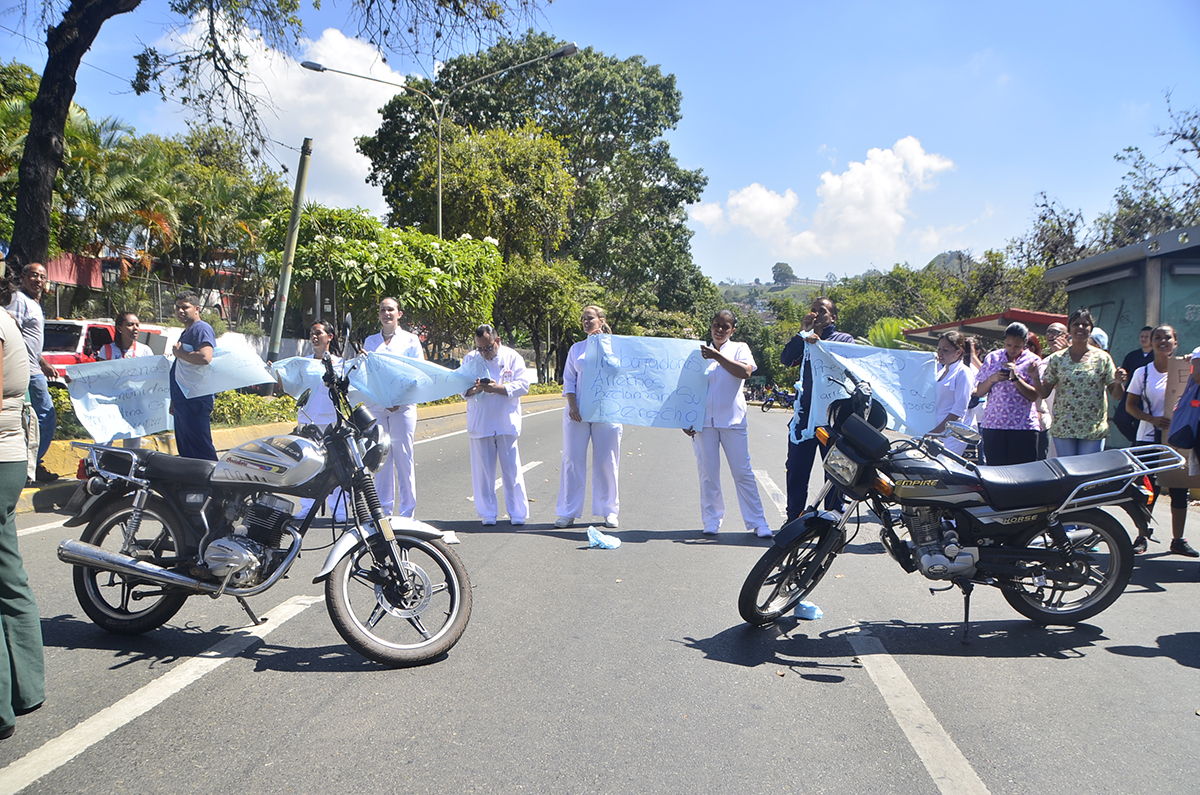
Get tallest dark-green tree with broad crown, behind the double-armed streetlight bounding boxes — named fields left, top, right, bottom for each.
left=358, top=31, right=712, bottom=324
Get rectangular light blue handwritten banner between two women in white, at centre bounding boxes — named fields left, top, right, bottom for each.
left=577, top=334, right=708, bottom=429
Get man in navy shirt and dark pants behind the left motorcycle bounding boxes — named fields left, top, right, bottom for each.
left=170, top=292, right=217, bottom=461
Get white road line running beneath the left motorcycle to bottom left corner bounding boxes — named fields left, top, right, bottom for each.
left=0, top=596, right=324, bottom=795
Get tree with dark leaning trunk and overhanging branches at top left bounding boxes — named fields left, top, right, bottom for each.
left=10, top=0, right=538, bottom=271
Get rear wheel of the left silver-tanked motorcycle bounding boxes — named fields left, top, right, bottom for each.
left=73, top=497, right=190, bottom=635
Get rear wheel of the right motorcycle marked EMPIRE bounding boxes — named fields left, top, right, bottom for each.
left=1003, top=508, right=1133, bottom=626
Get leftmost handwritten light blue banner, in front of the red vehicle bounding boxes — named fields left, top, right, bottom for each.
left=66, top=357, right=174, bottom=442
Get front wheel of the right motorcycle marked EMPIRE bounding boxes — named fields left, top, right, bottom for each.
left=738, top=524, right=839, bottom=627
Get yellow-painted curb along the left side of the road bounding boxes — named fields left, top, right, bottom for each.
left=17, top=395, right=565, bottom=514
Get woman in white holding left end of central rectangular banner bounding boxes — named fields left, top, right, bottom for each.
left=554, top=305, right=622, bottom=527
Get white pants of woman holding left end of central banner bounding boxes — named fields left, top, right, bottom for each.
left=557, top=411, right=622, bottom=519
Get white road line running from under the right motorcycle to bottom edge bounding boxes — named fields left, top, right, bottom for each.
left=847, top=633, right=988, bottom=795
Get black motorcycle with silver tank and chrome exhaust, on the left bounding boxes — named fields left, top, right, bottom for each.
left=58, top=326, right=472, bottom=668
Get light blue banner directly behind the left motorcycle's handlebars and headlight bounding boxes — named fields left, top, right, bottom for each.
left=347, top=351, right=476, bottom=408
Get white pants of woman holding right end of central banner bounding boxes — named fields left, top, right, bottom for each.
left=691, top=428, right=769, bottom=532
